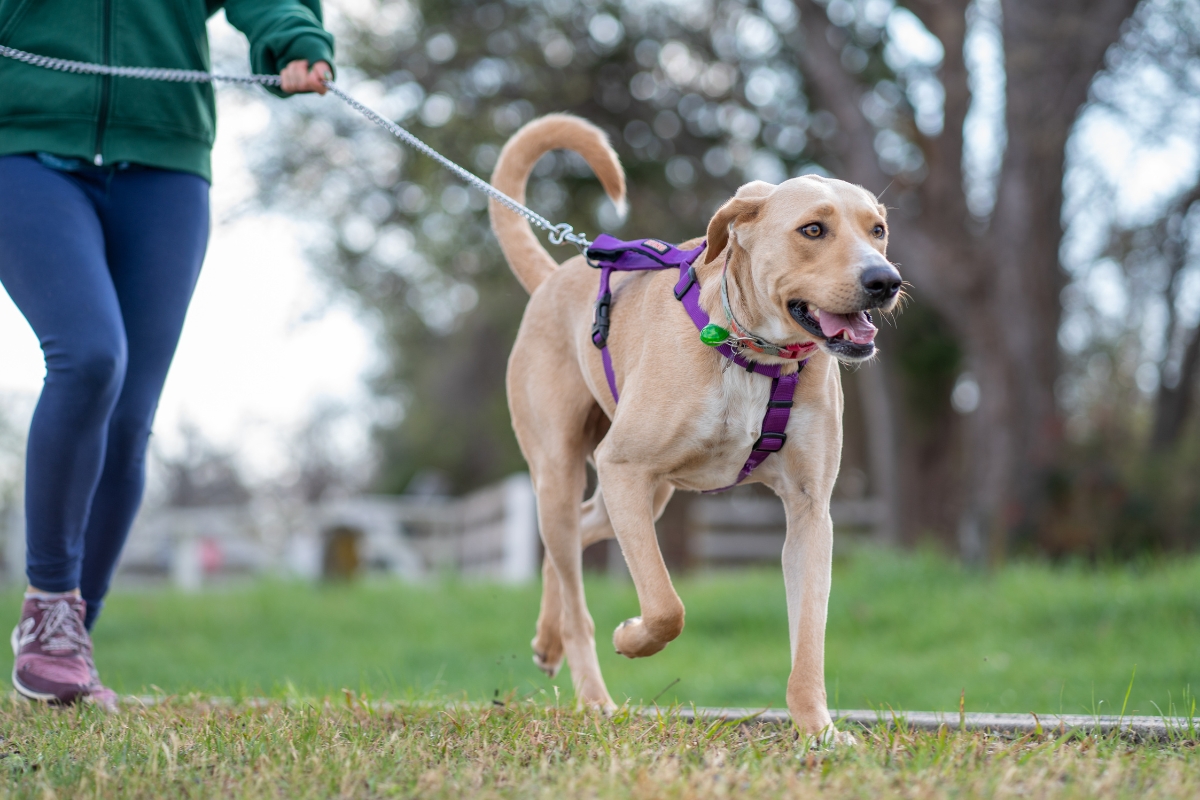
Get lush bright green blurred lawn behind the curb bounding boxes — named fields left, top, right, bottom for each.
left=0, top=552, right=1200, bottom=715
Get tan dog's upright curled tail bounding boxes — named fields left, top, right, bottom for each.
left=488, top=114, right=625, bottom=293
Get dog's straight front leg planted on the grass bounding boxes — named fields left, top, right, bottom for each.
left=784, top=489, right=834, bottom=738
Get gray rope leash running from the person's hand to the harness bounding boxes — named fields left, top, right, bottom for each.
left=0, top=44, right=592, bottom=253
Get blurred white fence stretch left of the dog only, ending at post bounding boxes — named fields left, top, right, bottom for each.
left=5, top=474, right=540, bottom=589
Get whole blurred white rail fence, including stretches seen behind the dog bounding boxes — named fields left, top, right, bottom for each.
left=0, top=474, right=886, bottom=589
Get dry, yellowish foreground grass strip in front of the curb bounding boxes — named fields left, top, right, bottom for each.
left=0, top=699, right=1200, bottom=800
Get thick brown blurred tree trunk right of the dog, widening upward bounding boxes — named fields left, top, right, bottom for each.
left=964, top=0, right=1136, bottom=555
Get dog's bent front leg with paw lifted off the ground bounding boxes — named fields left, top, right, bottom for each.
left=596, top=456, right=684, bottom=658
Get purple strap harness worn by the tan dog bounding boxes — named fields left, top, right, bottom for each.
left=587, top=234, right=808, bottom=492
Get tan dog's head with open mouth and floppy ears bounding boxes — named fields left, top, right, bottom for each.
left=707, top=175, right=901, bottom=361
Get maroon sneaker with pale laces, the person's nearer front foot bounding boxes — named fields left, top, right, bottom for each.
left=12, top=595, right=98, bottom=703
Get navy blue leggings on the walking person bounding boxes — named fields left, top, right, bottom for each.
left=0, top=156, right=209, bottom=627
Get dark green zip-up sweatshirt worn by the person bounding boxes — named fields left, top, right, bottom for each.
left=0, top=0, right=334, bottom=180
